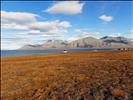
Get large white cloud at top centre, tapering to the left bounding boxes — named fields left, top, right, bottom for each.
left=44, top=1, right=84, bottom=15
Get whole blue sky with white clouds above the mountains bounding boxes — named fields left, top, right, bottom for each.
left=1, top=1, right=133, bottom=50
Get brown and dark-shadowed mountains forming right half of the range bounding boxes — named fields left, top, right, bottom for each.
left=68, top=36, right=133, bottom=48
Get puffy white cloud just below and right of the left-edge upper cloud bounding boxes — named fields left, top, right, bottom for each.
left=28, top=20, right=72, bottom=35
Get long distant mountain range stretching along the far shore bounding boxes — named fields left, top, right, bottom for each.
left=20, top=36, right=133, bottom=50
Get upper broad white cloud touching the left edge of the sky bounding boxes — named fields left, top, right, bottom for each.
left=1, top=11, right=39, bottom=30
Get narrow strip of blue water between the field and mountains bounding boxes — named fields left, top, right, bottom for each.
left=1, top=48, right=112, bottom=57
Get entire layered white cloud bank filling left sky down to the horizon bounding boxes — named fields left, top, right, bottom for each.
left=1, top=11, right=72, bottom=49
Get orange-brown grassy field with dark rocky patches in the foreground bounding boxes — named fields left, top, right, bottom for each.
left=1, top=51, right=133, bottom=100
